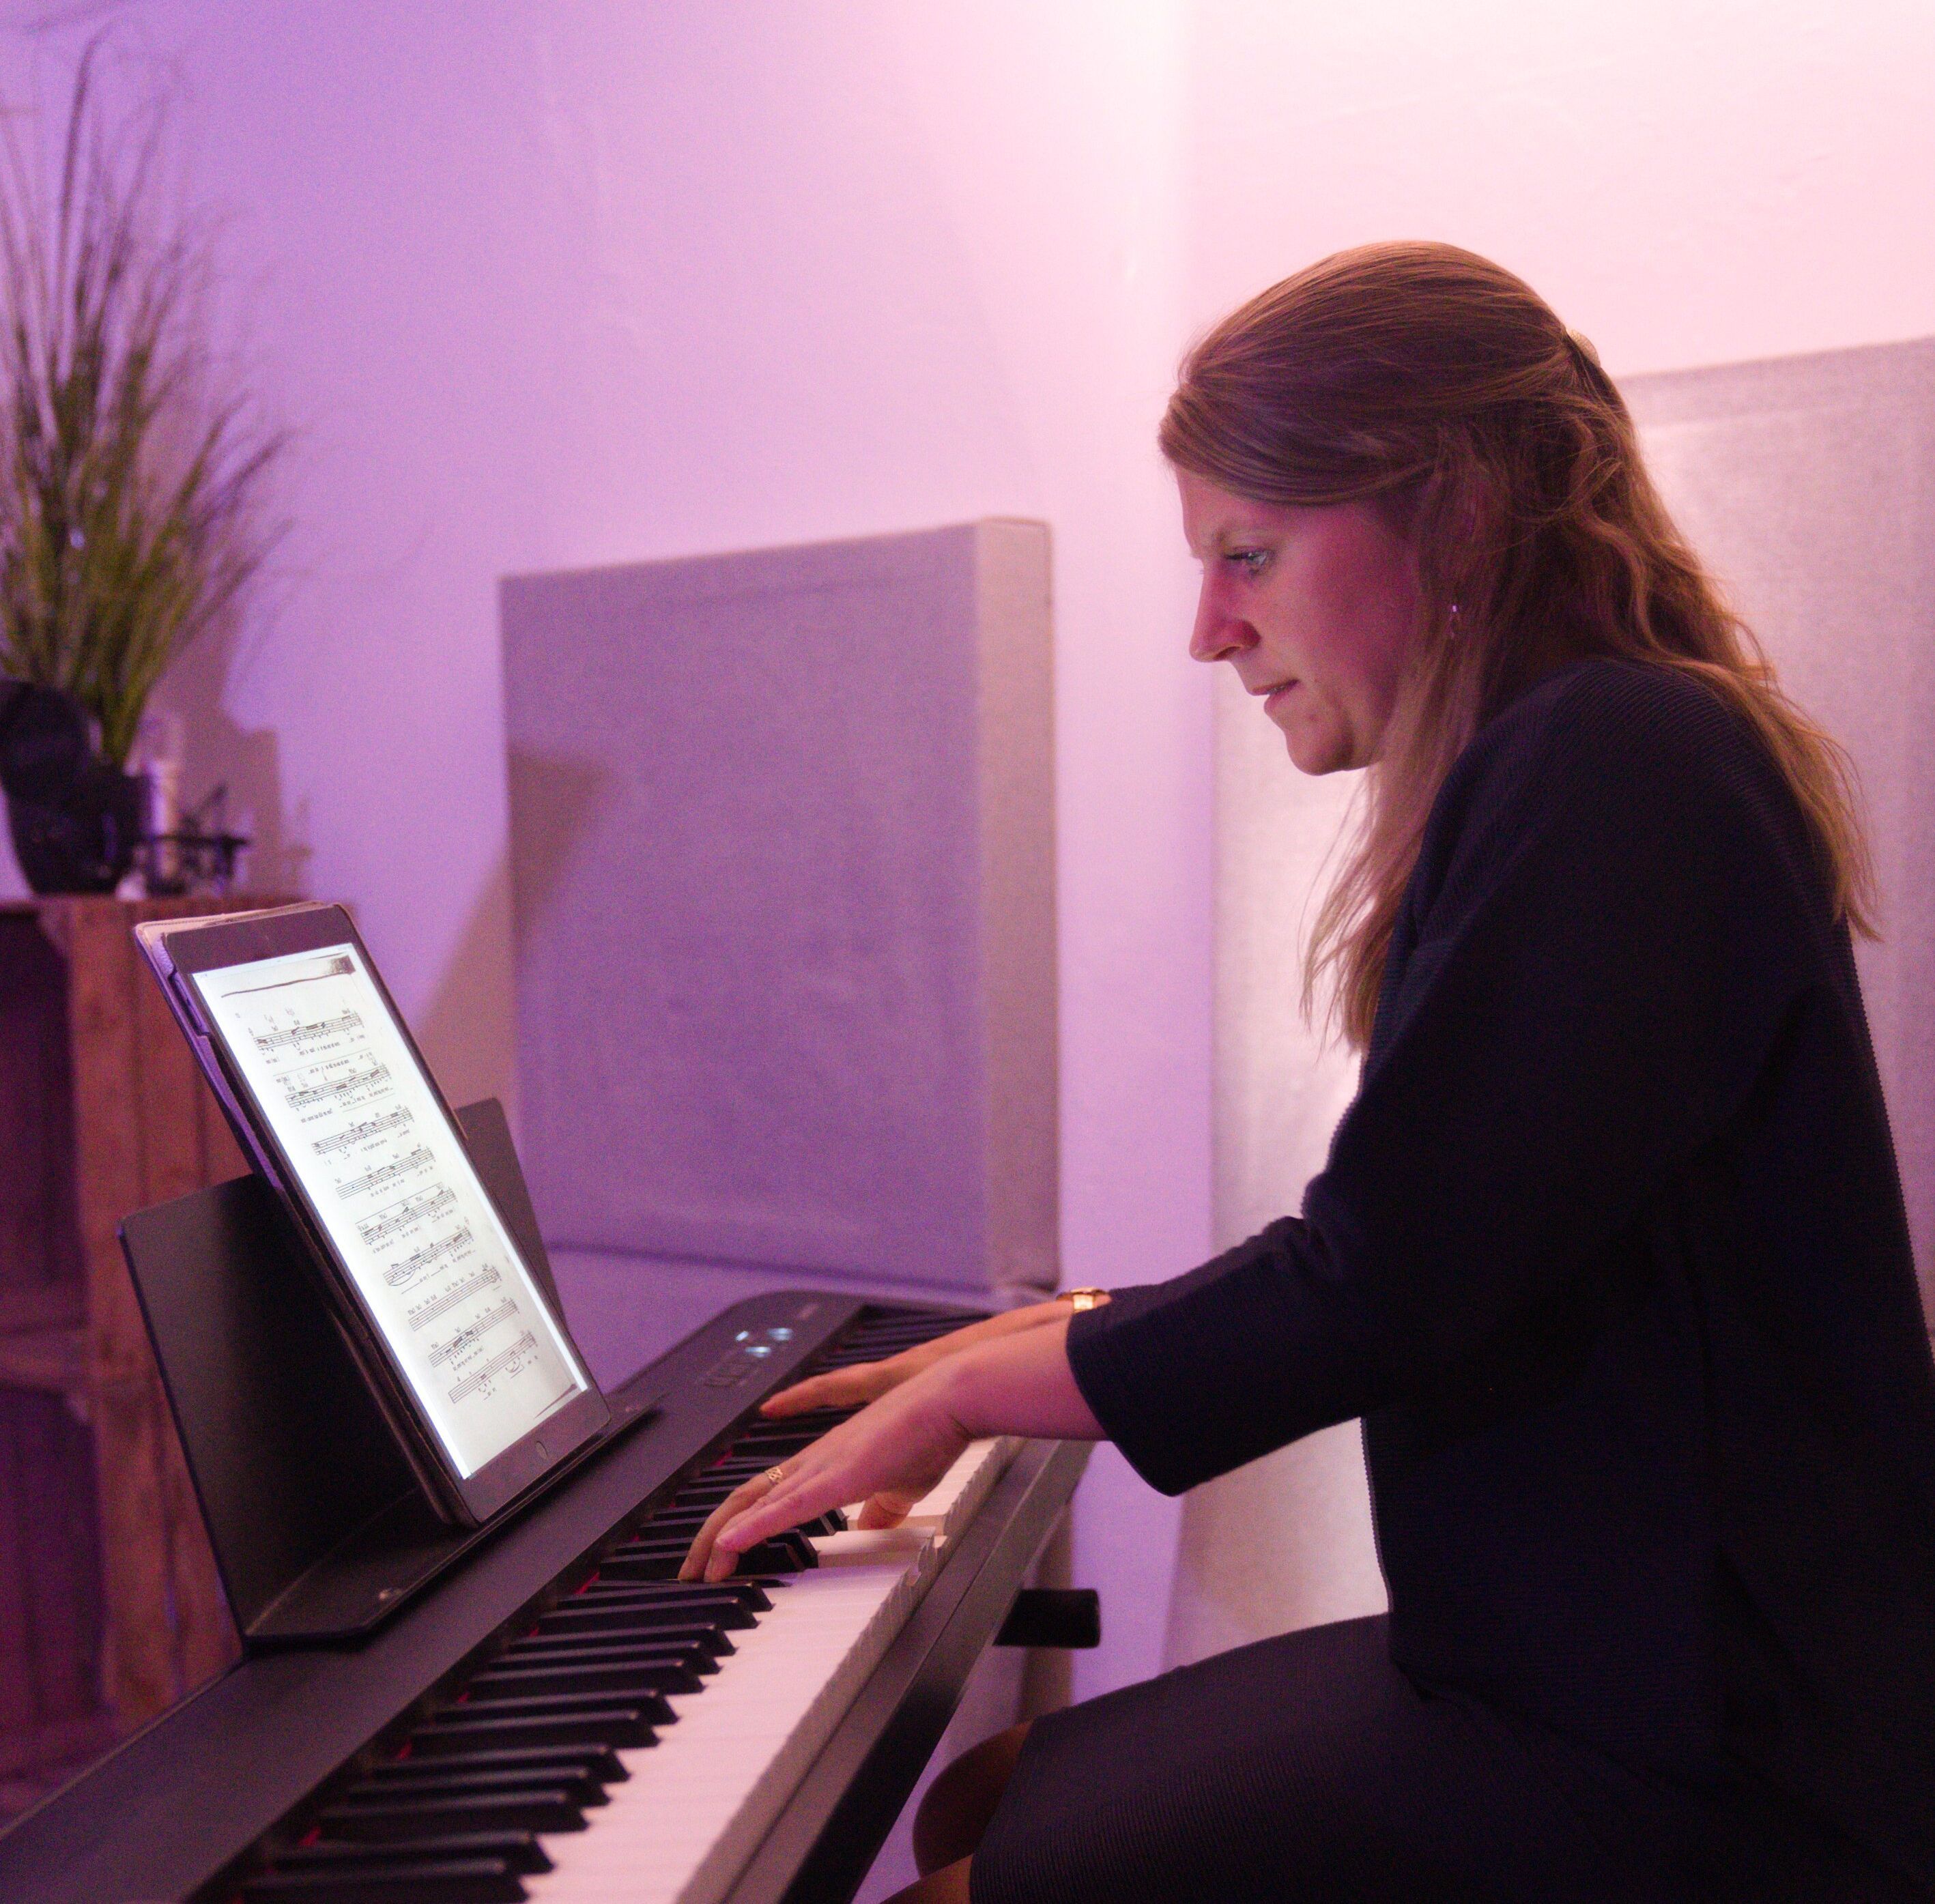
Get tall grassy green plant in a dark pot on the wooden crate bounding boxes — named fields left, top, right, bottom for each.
left=0, top=39, right=287, bottom=892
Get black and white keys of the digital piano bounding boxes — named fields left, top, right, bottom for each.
left=242, top=1316, right=1018, bottom=1904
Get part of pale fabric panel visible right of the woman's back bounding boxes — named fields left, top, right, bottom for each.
left=1622, top=338, right=1935, bottom=1323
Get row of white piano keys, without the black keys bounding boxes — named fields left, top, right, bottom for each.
left=524, top=1438, right=1020, bottom=1904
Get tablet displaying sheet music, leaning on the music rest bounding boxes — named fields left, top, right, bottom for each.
left=135, top=906, right=610, bottom=1525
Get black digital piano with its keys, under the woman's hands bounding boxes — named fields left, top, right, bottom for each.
left=0, top=1293, right=1080, bottom=1904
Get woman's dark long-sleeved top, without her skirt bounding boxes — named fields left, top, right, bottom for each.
left=1068, top=662, right=1935, bottom=1883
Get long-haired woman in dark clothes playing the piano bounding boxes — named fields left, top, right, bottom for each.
left=689, top=244, right=1935, bottom=1904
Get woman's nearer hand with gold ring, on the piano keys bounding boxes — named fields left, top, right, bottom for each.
left=679, top=1368, right=973, bottom=1581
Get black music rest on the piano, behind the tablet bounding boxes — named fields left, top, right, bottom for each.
left=120, top=1099, right=646, bottom=1649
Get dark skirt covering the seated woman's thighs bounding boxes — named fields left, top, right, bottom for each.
left=973, top=1617, right=1912, bottom=1904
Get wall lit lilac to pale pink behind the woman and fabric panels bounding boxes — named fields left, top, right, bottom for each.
left=0, top=0, right=1935, bottom=1710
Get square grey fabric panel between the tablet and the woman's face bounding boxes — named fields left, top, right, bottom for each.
left=501, top=523, right=1057, bottom=1288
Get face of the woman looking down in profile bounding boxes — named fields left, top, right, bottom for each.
left=1177, top=470, right=1424, bottom=774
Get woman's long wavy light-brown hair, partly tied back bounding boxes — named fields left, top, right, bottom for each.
left=1161, top=244, right=1875, bottom=1049
